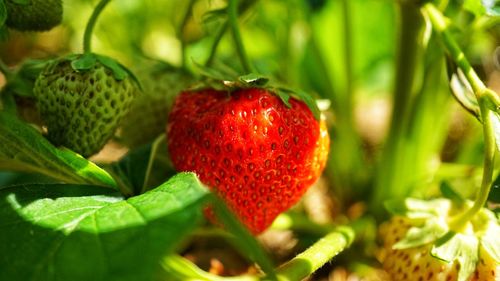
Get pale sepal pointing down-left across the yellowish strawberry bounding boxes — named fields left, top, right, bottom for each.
left=393, top=218, right=448, bottom=249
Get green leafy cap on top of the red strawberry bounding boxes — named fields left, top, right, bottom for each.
left=193, top=62, right=321, bottom=120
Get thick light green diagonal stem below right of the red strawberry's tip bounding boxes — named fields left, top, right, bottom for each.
left=277, top=227, right=354, bottom=281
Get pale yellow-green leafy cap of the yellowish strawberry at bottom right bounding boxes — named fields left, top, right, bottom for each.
left=386, top=198, right=500, bottom=281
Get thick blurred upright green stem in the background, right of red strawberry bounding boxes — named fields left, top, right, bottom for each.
left=372, top=1, right=423, bottom=212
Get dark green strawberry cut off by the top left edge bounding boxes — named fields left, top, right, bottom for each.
left=5, top=0, right=63, bottom=31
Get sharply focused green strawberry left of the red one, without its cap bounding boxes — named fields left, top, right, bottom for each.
left=34, top=54, right=137, bottom=157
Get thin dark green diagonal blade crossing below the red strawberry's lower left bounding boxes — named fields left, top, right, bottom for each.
left=212, top=195, right=276, bottom=279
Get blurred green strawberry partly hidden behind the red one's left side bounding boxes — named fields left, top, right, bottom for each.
left=119, top=64, right=193, bottom=147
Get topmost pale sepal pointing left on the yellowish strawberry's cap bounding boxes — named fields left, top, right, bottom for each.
left=384, top=198, right=451, bottom=219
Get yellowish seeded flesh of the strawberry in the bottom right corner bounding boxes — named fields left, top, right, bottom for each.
left=380, top=216, right=500, bottom=281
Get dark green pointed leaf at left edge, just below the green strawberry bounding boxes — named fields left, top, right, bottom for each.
left=0, top=111, right=116, bottom=187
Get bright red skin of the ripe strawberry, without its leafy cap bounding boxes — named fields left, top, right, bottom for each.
left=167, top=88, right=330, bottom=234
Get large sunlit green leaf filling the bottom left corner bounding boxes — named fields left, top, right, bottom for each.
left=0, top=173, right=208, bottom=281
